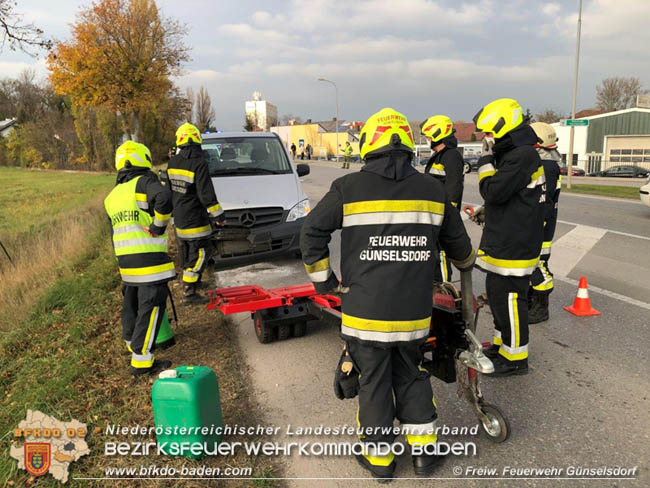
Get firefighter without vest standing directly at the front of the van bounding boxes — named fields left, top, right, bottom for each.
left=167, top=124, right=225, bottom=304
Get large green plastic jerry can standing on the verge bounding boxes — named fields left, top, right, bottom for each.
left=151, top=366, right=223, bottom=459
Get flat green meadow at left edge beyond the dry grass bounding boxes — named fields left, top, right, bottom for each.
left=0, top=168, right=115, bottom=240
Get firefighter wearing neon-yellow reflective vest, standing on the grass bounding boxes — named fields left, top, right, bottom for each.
left=104, top=141, right=176, bottom=376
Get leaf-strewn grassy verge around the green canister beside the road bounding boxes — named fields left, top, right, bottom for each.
left=0, top=169, right=276, bottom=487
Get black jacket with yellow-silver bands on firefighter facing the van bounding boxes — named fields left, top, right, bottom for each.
left=167, top=144, right=223, bottom=239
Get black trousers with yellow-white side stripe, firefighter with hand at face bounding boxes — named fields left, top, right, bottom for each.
left=485, top=271, right=531, bottom=361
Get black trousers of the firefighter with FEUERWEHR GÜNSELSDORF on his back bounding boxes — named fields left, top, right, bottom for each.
left=347, top=341, right=437, bottom=466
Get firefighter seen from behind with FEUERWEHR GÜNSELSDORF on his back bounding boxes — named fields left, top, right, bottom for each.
left=301, top=108, right=474, bottom=478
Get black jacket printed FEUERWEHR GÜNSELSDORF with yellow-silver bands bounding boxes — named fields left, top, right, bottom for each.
left=300, top=151, right=474, bottom=347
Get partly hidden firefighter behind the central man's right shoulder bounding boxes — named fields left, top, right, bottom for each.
left=421, top=115, right=465, bottom=282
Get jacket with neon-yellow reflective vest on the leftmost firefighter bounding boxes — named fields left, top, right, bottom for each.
left=104, top=169, right=176, bottom=286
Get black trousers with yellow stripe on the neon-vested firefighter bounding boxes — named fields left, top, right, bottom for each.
left=122, top=283, right=169, bottom=368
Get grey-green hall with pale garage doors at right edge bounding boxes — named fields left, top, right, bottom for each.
left=551, top=107, right=650, bottom=173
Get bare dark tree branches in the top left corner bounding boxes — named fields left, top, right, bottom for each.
left=0, top=0, right=52, bottom=56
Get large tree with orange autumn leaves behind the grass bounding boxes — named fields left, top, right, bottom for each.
left=48, top=0, right=189, bottom=140
